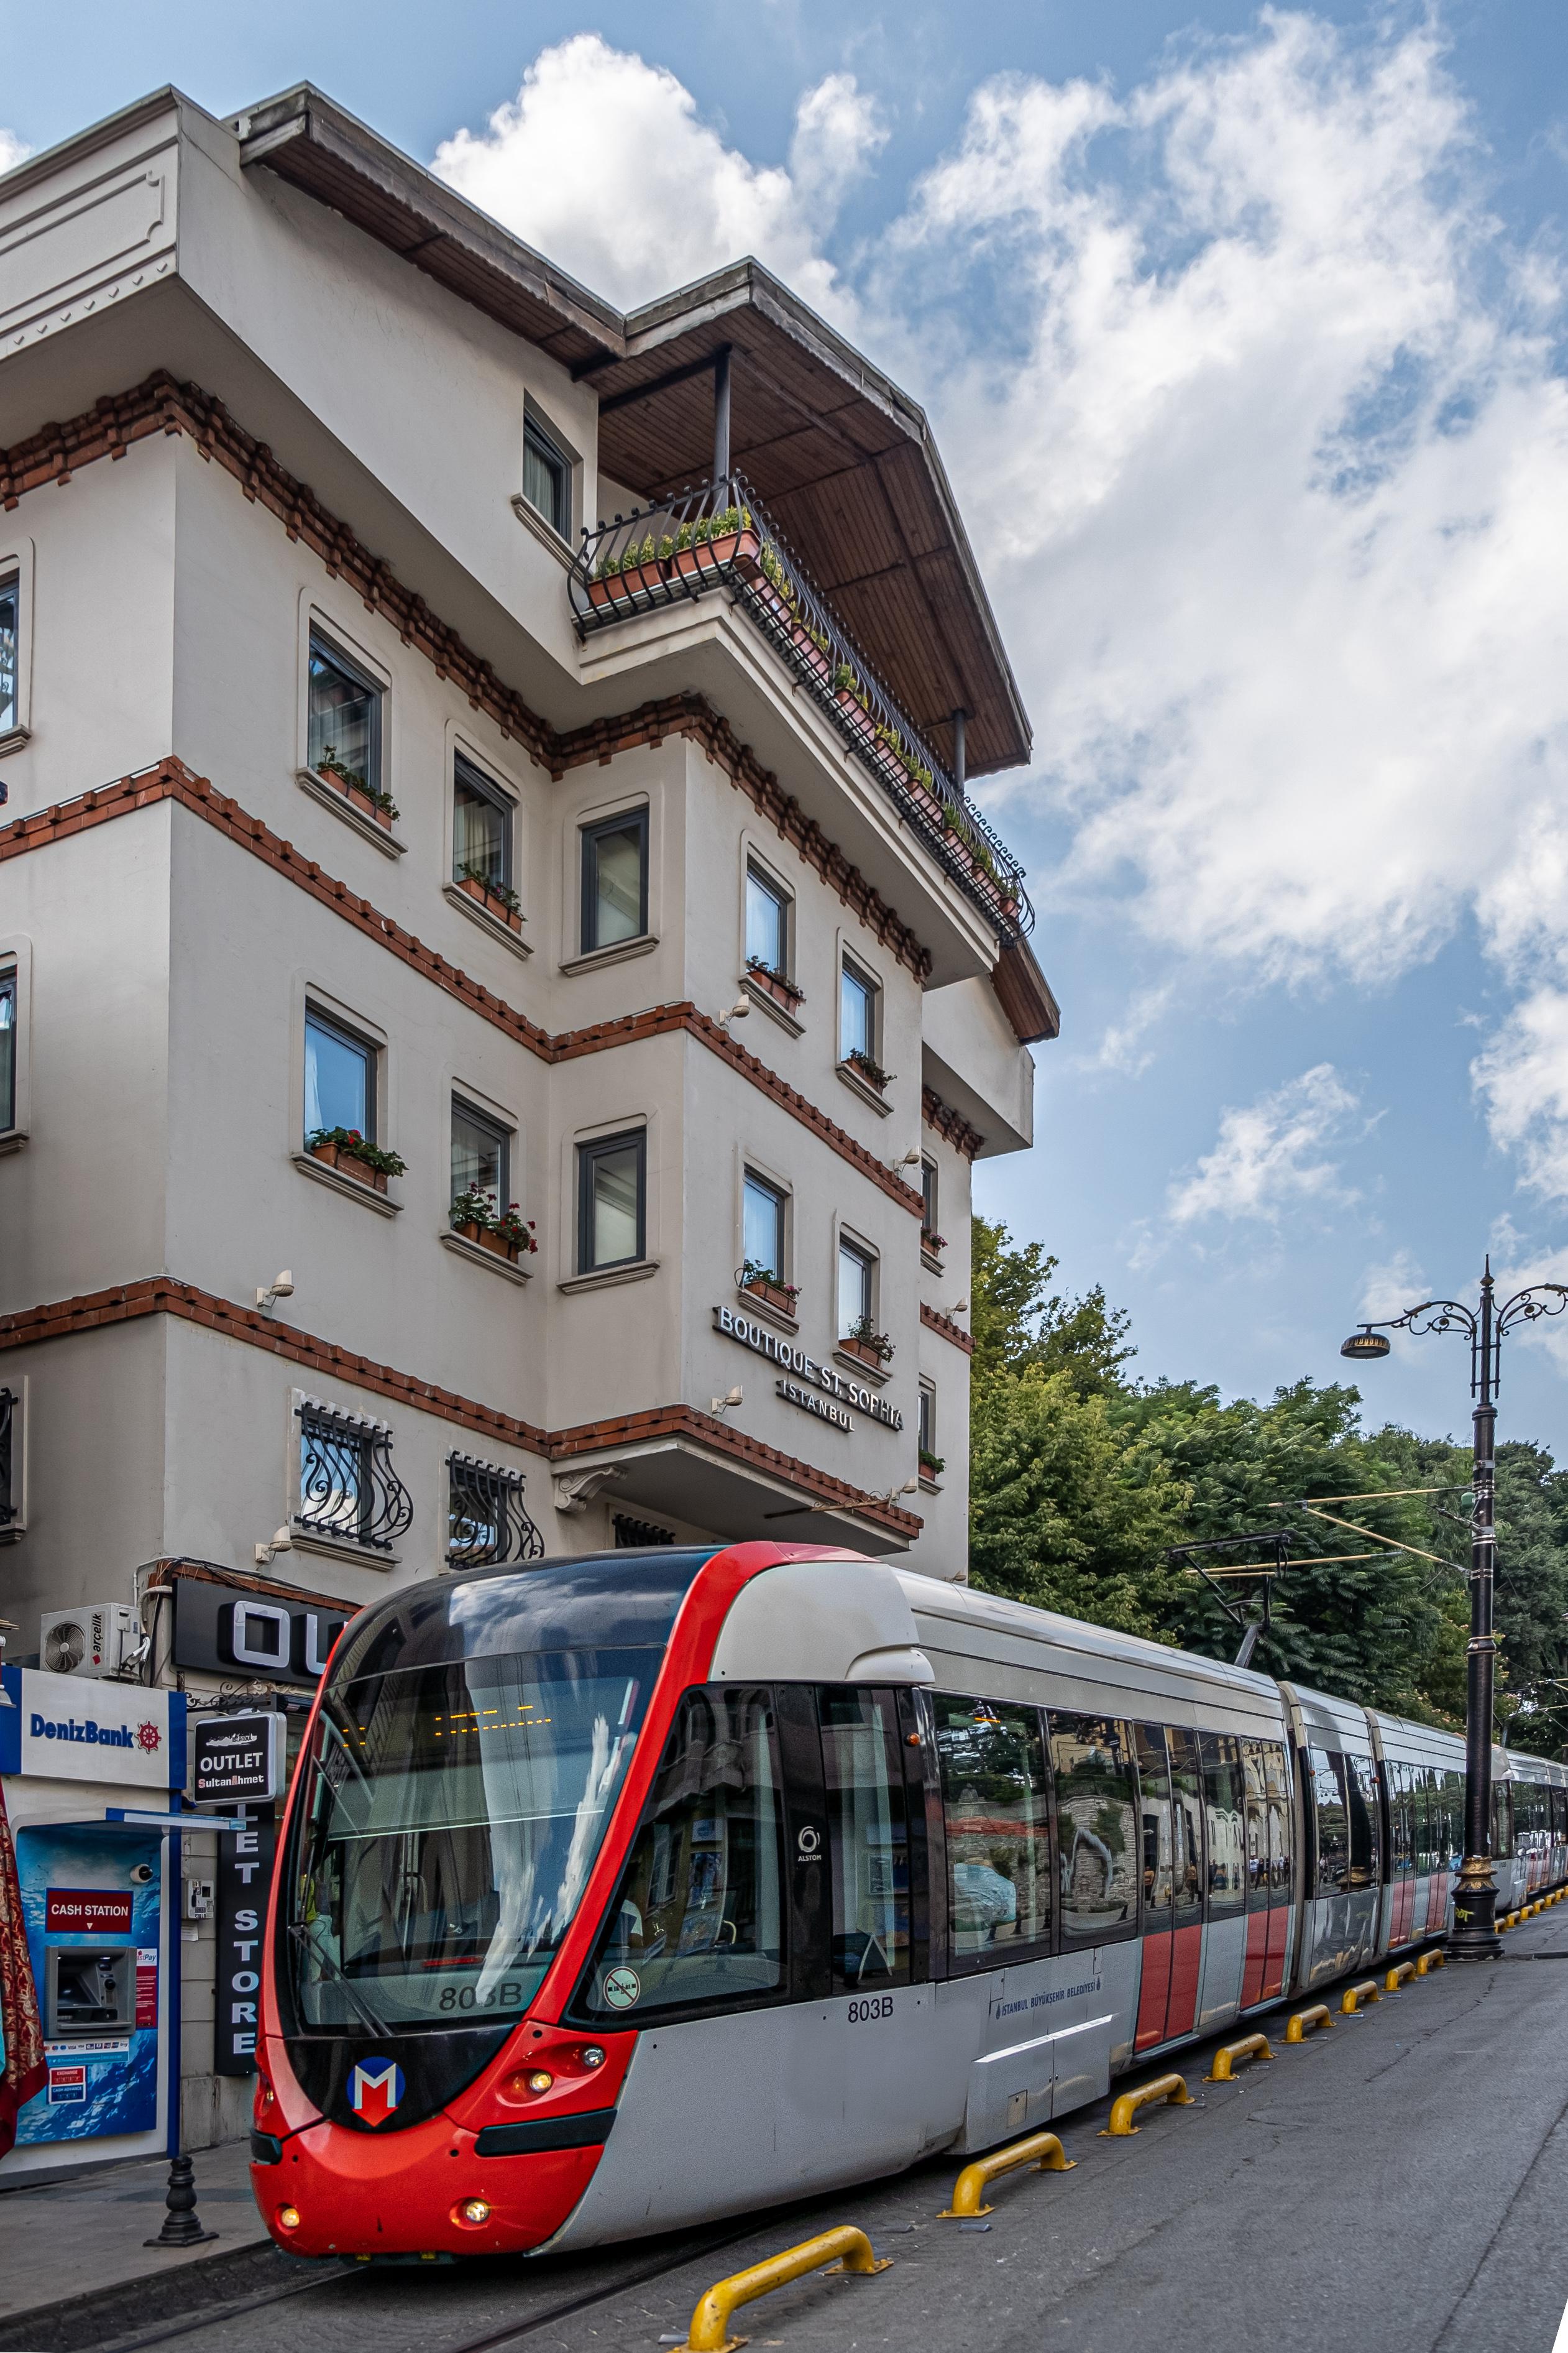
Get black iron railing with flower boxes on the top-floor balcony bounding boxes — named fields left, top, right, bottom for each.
left=569, top=473, right=1034, bottom=939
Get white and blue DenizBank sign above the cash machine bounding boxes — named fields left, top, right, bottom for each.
left=0, top=1666, right=186, bottom=1790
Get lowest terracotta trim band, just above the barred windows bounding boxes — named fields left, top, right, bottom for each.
left=0, top=1275, right=924, bottom=1539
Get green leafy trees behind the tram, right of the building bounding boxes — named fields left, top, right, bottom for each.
left=968, top=1219, right=1568, bottom=1756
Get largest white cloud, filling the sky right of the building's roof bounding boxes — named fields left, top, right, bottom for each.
left=879, top=12, right=1568, bottom=979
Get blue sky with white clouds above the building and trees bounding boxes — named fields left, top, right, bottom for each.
left=0, top=0, right=1568, bottom=1457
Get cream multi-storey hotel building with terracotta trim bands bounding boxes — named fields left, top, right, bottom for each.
left=0, top=90, right=1055, bottom=2139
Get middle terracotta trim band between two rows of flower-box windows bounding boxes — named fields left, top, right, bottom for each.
left=0, top=758, right=922, bottom=1217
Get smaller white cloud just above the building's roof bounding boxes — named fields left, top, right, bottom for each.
left=433, top=33, right=886, bottom=318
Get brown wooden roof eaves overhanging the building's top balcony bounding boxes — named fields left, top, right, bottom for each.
left=231, top=82, right=1030, bottom=776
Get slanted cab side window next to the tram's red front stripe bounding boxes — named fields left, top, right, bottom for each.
left=580, top=1685, right=785, bottom=2024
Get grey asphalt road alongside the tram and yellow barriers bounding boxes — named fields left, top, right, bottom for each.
left=12, top=1904, right=1568, bottom=2353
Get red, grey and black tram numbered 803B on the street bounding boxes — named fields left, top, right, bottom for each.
left=252, top=1544, right=1568, bottom=2254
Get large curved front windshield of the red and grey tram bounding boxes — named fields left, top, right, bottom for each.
left=277, top=1649, right=663, bottom=2035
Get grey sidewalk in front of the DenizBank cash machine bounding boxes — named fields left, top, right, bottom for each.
left=0, top=2141, right=265, bottom=2320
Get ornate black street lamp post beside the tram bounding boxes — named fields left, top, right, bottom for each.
left=1340, top=1256, right=1568, bottom=1960
